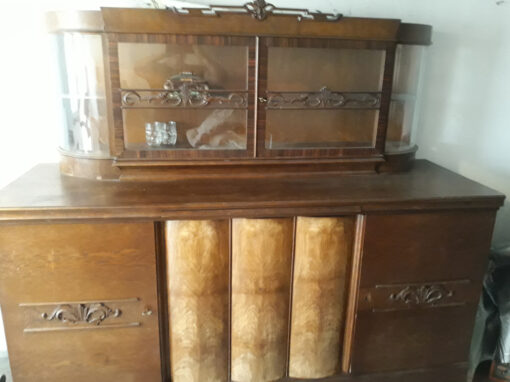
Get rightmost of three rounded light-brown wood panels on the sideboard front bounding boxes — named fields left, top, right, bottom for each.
left=289, top=217, right=354, bottom=378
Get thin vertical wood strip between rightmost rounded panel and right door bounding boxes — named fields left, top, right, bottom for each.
left=342, top=215, right=366, bottom=373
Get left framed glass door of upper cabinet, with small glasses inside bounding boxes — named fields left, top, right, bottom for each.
left=109, top=34, right=255, bottom=159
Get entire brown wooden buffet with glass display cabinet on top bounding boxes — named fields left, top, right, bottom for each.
left=0, top=1, right=504, bottom=382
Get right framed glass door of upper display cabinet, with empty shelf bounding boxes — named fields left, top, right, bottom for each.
left=258, top=38, right=393, bottom=157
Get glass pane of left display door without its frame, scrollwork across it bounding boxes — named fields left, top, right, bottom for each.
left=119, top=42, right=248, bottom=150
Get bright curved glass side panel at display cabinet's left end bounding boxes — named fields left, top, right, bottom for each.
left=55, top=33, right=109, bottom=157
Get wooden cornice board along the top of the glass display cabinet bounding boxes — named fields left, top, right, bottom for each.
left=46, top=6, right=432, bottom=45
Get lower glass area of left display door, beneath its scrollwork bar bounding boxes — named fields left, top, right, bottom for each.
left=123, top=108, right=247, bottom=150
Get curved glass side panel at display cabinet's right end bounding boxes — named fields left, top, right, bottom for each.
left=386, top=45, right=425, bottom=152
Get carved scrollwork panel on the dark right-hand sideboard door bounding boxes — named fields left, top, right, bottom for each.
left=359, top=280, right=480, bottom=312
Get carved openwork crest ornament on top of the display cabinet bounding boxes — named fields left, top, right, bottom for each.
left=167, top=0, right=342, bottom=21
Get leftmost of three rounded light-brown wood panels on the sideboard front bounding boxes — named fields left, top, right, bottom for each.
left=166, top=220, right=229, bottom=382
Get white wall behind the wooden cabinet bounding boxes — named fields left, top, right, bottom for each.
left=0, top=0, right=510, bottom=353
